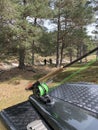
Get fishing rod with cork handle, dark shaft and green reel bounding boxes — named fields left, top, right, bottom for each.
left=25, top=47, right=98, bottom=102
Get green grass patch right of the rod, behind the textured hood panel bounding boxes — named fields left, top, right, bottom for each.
left=56, top=63, right=98, bottom=83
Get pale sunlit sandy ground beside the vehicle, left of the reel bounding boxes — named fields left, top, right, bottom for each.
left=0, top=80, right=32, bottom=110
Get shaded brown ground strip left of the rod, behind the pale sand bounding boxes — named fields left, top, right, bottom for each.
left=0, top=66, right=52, bottom=82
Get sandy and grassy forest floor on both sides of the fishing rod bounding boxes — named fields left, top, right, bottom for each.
left=0, top=55, right=98, bottom=110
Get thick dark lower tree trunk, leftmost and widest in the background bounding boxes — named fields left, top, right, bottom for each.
left=19, top=48, right=25, bottom=69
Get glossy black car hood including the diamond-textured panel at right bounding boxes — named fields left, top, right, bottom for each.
left=29, top=84, right=98, bottom=130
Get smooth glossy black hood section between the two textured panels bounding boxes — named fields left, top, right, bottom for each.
left=30, top=96, right=98, bottom=130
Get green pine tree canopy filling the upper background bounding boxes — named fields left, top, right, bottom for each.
left=0, top=0, right=93, bottom=69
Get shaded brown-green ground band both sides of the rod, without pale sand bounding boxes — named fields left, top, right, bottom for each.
left=0, top=63, right=98, bottom=82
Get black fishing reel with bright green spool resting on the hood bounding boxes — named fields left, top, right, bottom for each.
left=28, top=81, right=51, bottom=103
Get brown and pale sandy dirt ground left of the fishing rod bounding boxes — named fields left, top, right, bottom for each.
left=0, top=64, right=55, bottom=110
